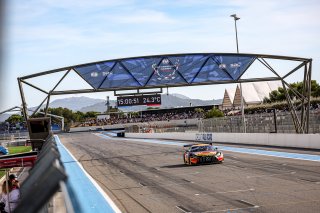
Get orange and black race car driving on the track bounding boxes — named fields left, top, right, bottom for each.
left=183, top=144, right=224, bottom=165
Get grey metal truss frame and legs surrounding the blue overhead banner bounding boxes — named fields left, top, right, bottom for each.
left=17, top=53, right=312, bottom=134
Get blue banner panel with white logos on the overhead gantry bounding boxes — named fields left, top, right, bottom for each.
left=74, top=54, right=256, bottom=89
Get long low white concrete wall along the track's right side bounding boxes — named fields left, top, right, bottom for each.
left=125, top=133, right=320, bottom=149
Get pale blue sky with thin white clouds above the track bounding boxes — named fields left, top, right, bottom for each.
left=0, top=0, right=320, bottom=112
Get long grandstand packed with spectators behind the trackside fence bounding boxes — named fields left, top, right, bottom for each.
left=77, top=102, right=320, bottom=133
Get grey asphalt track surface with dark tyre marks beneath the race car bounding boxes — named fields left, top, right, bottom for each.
left=59, top=133, right=320, bottom=213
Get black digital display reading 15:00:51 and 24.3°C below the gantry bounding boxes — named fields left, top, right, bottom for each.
left=117, top=94, right=161, bottom=107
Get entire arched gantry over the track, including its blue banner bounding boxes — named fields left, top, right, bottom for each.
left=18, top=53, right=312, bottom=133
